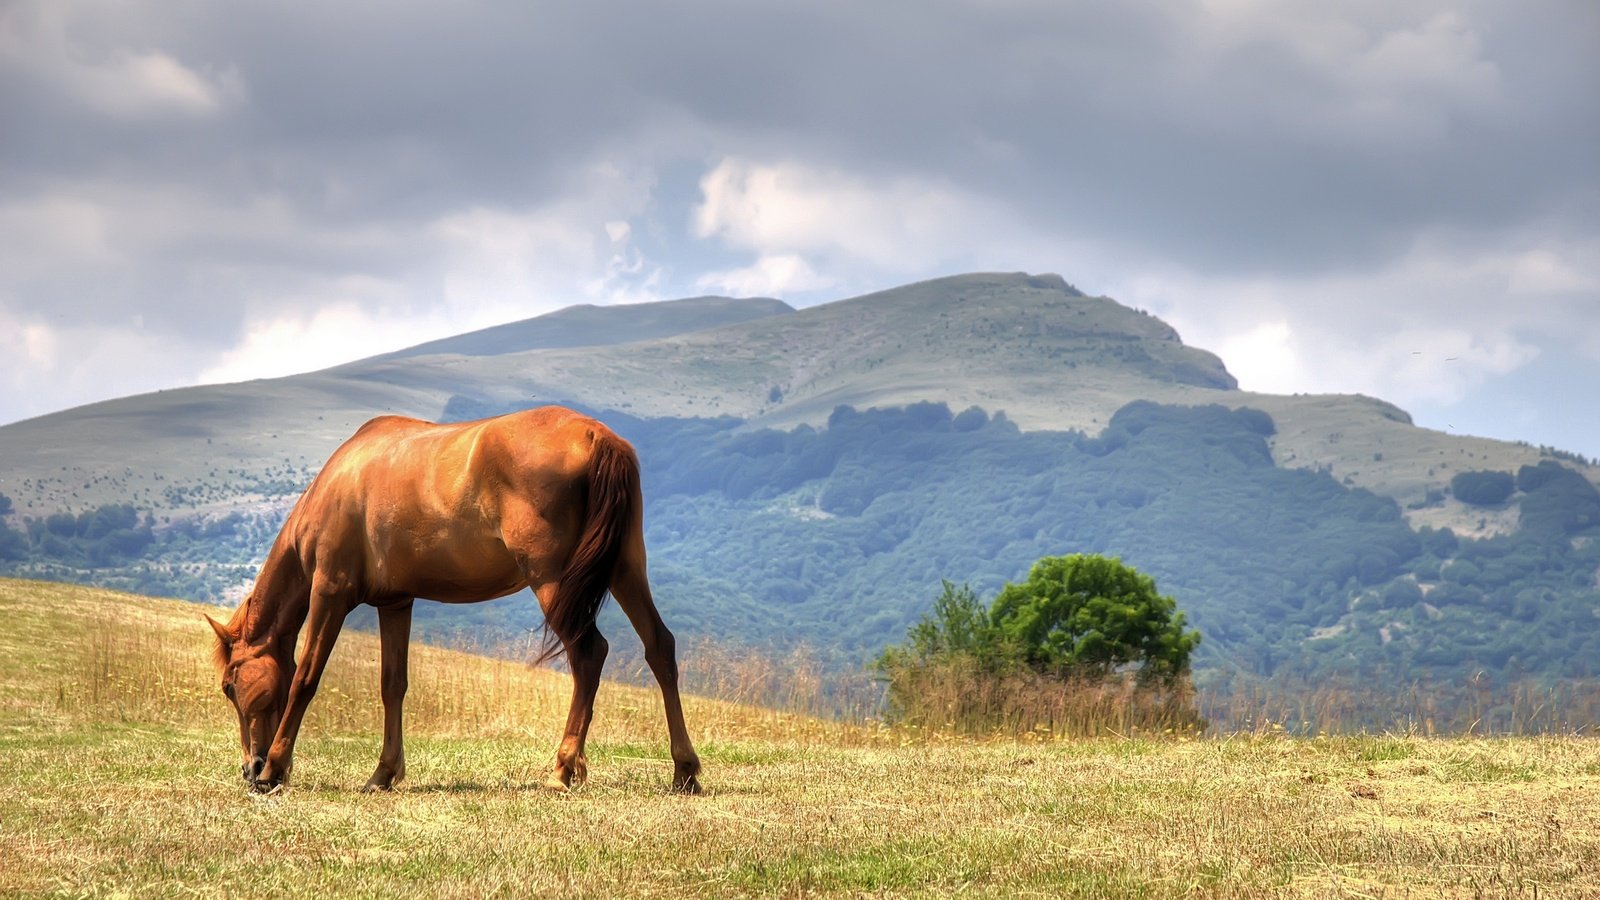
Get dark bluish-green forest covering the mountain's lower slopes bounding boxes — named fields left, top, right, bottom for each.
left=0, top=397, right=1600, bottom=704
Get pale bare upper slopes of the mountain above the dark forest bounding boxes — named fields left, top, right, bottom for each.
left=0, top=272, right=1600, bottom=533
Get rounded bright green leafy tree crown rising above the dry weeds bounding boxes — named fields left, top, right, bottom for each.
left=989, top=554, right=1200, bottom=682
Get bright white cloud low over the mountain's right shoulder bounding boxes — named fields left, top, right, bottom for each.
left=1109, top=222, right=1600, bottom=405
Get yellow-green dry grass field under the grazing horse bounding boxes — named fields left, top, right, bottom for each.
left=0, top=570, right=1600, bottom=897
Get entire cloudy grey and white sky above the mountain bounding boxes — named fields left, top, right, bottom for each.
left=0, top=0, right=1600, bottom=456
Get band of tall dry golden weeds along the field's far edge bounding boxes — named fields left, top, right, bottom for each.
left=53, top=598, right=1600, bottom=741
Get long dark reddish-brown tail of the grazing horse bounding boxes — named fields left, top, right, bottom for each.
left=539, top=431, right=640, bottom=663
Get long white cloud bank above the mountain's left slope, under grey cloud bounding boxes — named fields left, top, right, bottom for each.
left=0, top=158, right=662, bottom=421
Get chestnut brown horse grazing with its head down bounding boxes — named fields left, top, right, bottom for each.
left=206, top=407, right=699, bottom=793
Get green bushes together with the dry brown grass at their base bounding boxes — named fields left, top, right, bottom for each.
left=877, top=556, right=1205, bottom=735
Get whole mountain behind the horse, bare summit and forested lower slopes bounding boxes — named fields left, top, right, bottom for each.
left=0, top=274, right=1600, bottom=707
